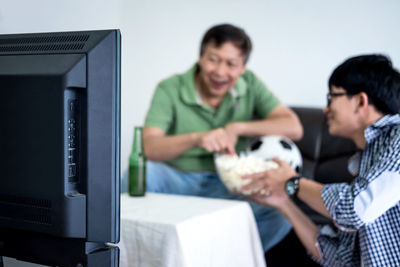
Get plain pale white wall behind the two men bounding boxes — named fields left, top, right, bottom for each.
left=0, top=0, right=400, bottom=188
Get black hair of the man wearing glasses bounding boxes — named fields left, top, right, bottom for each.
left=328, top=54, right=400, bottom=114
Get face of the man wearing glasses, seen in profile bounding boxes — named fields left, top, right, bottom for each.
left=324, top=86, right=360, bottom=138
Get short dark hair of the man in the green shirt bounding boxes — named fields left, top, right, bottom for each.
left=200, top=24, right=252, bottom=63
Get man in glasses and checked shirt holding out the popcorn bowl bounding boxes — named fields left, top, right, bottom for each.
left=243, top=55, right=400, bottom=266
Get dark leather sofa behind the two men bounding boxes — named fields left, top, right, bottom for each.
left=266, top=107, right=357, bottom=267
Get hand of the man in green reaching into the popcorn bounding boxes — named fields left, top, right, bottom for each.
left=199, top=128, right=235, bottom=155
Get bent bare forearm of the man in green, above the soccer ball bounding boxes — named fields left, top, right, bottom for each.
left=225, top=104, right=303, bottom=141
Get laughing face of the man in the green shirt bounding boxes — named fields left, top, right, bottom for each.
left=198, top=42, right=246, bottom=97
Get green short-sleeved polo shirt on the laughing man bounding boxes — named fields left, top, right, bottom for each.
left=145, top=64, right=280, bottom=172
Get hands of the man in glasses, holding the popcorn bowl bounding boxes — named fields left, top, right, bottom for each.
left=242, top=159, right=296, bottom=208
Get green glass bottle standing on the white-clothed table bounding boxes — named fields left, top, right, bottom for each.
left=129, top=127, right=146, bottom=196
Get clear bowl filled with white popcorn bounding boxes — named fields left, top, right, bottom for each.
left=215, top=154, right=278, bottom=195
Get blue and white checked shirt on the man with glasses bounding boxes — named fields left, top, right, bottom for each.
left=317, top=114, right=400, bottom=266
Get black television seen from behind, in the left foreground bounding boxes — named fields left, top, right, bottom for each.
left=0, top=30, right=121, bottom=267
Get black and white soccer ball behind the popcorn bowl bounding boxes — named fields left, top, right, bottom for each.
left=246, top=135, right=303, bottom=173
